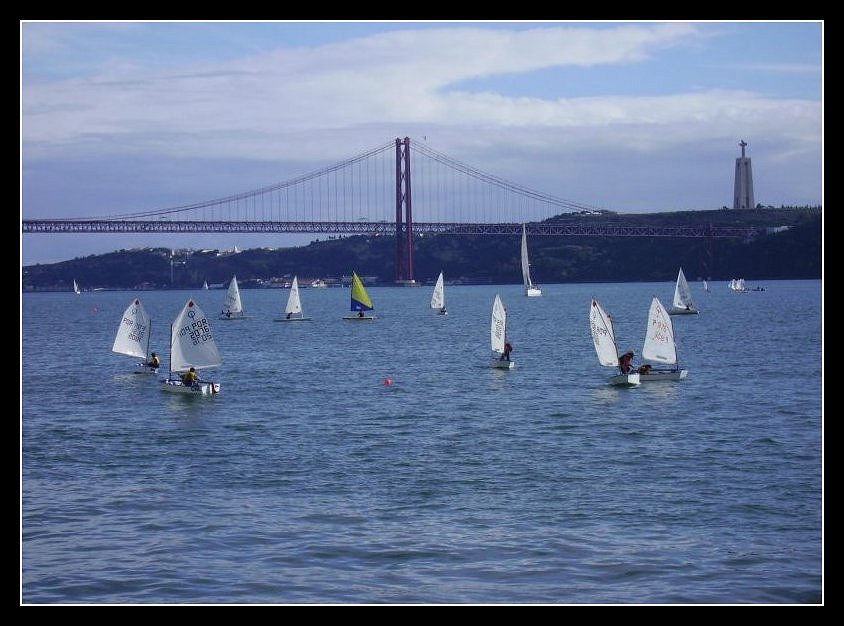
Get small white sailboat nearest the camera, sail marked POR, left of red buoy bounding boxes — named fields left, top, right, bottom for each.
left=161, top=300, right=223, bottom=395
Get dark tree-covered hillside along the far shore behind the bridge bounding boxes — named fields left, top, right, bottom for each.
left=22, top=207, right=823, bottom=291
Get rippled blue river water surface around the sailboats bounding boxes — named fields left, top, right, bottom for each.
left=21, top=281, right=823, bottom=604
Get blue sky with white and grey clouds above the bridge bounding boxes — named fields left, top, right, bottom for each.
left=20, top=21, right=824, bottom=266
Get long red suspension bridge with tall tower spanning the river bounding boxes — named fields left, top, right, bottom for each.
left=22, top=137, right=762, bottom=283
